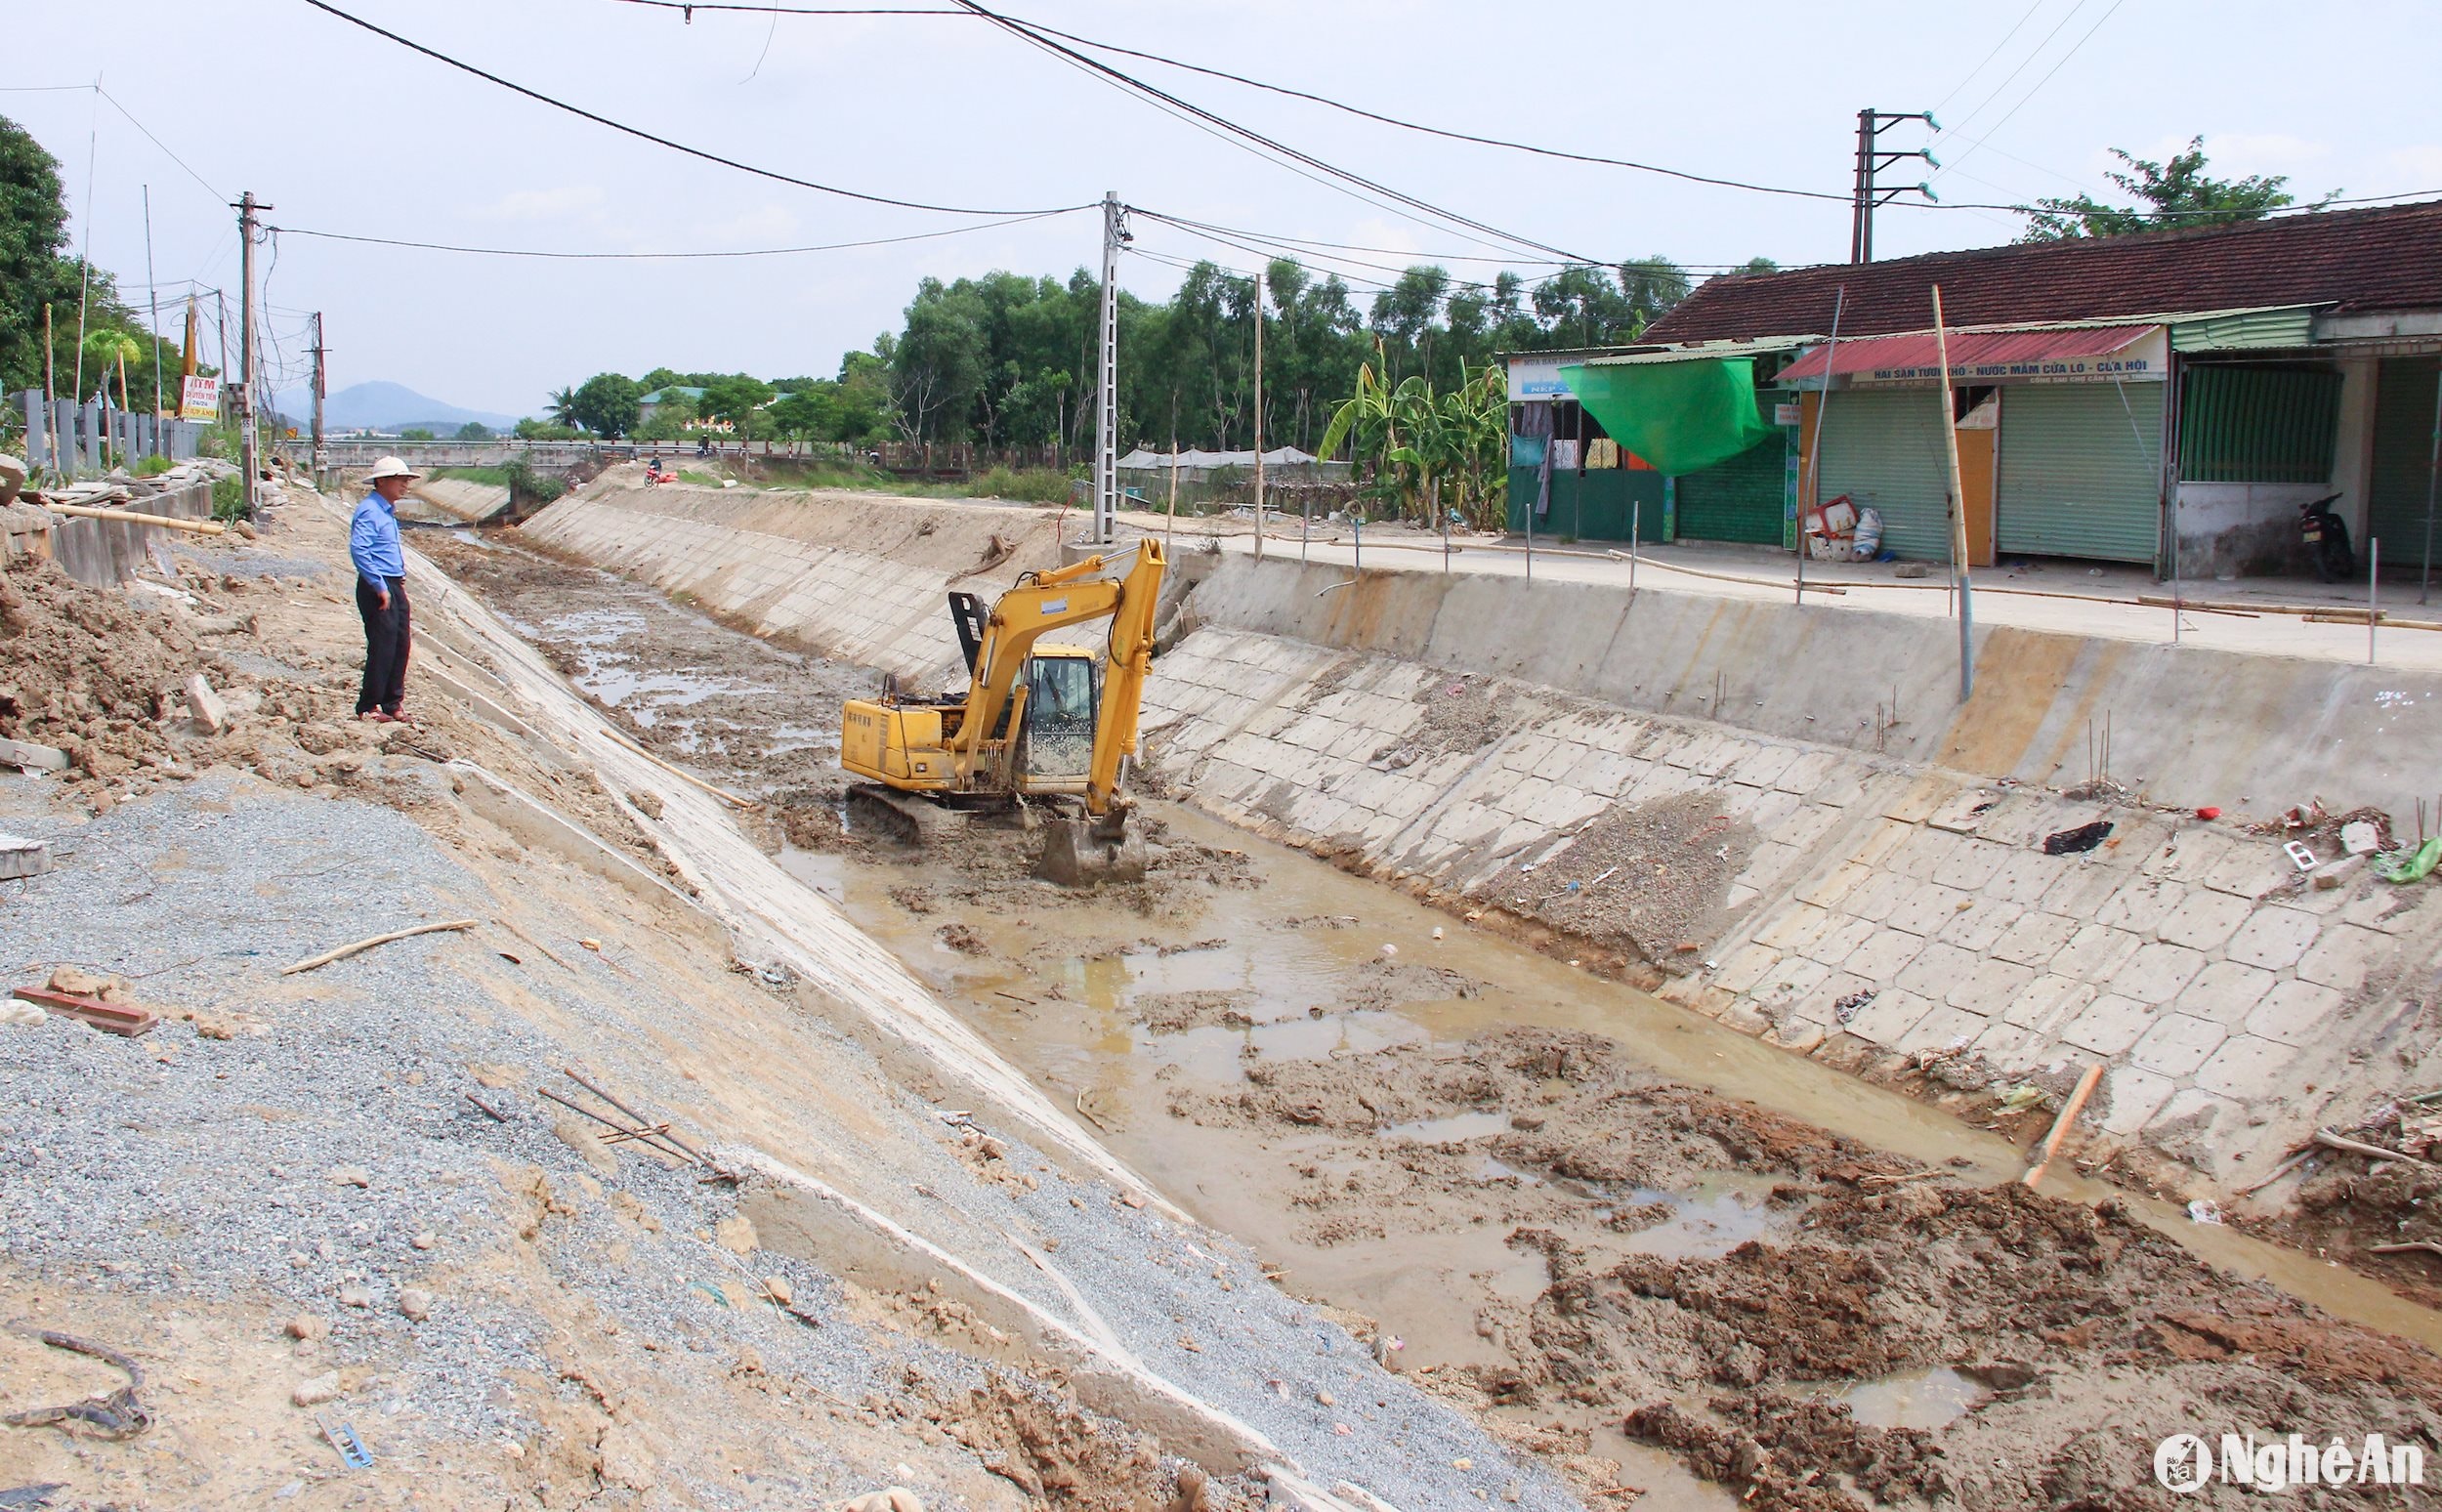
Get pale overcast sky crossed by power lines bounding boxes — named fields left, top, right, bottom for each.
left=0, top=0, right=2442, bottom=413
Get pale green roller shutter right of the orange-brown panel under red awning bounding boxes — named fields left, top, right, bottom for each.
left=1993, top=384, right=2164, bottom=562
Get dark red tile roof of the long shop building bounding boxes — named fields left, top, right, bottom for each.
left=1644, top=200, right=2442, bottom=342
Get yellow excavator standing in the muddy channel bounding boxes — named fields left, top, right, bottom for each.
left=840, top=537, right=1167, bottom=887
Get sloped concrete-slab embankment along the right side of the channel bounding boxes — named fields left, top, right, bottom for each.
left=510, top=496, right=2442, bottom=1206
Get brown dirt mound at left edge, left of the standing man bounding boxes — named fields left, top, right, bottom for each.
left=0, top=557, right=205, bottom=777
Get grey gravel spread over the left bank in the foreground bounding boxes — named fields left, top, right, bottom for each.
left=0, top=779, right=952, bottom=1475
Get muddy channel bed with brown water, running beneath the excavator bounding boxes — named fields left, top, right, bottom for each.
left=435, top=506, right=2442, bottom=1507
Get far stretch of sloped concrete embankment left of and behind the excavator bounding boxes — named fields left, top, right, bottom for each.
left=526, top=479, right=1060, bottom=687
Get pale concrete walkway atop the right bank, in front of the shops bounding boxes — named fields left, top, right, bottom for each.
left=1118, top=513, right=2442, bottom=669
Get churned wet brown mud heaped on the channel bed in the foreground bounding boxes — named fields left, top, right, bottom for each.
left=1170, top=1029, right=2442, bottom=1512
